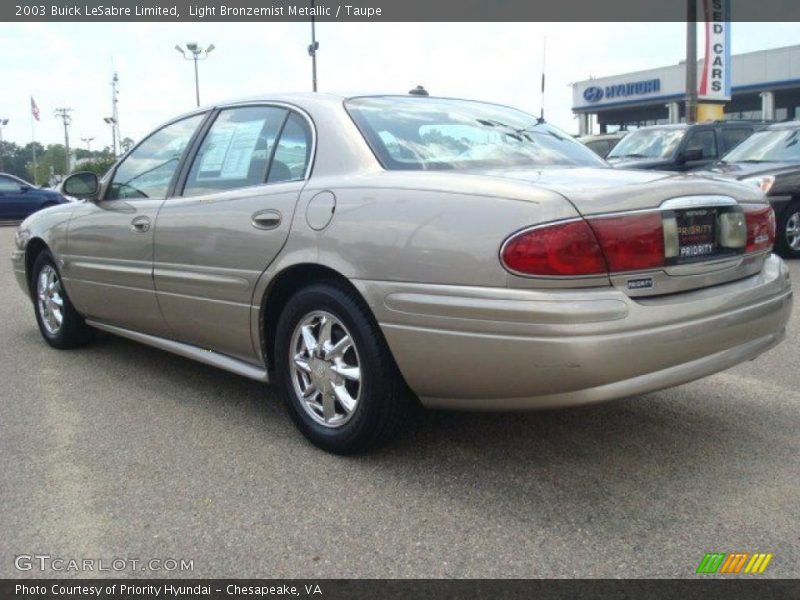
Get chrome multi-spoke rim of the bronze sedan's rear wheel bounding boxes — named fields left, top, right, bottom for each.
left=288, top=310, right=361, bottom=427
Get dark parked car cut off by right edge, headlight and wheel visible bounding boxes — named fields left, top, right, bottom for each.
left=709, top=121, right=800, bottom=258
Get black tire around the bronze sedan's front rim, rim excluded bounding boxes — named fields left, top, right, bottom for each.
left=30, top=250, right=96, bottom=350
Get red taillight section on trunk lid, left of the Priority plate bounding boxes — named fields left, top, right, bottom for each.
left=589, top=212, right=664, bottom=272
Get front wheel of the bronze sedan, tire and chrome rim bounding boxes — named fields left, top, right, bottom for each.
left=31, top=250, right=95, bottom=349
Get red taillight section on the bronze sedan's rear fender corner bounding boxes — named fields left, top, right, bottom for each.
left=501, top=219, right=608, bottom=276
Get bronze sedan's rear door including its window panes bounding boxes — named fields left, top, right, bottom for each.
left=154, top=105, right=313, bottom=359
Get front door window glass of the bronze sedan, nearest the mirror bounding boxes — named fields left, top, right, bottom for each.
left=105, top=114, right=205, bottom=200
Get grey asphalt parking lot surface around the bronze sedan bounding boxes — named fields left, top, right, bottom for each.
left=0, top=227, right=800, bottom=578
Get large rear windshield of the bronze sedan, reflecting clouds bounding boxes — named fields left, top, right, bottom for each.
left=345, top=97, right=606, bottom=170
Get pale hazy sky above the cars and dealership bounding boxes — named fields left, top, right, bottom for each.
left=0, top=22, right=800, bottom=149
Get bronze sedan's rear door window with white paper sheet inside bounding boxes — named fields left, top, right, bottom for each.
left=183, top=106, right=288, bottom=196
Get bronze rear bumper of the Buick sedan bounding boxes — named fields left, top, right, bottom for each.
left=355, top=251, right=792, bottom=410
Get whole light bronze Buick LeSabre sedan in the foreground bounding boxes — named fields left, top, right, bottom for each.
left=13, top=94, right=792, bottom=452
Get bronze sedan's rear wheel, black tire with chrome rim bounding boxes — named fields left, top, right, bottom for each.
left=275, top=283, right=409, bottom=454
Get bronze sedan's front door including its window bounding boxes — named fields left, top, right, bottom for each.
left=62, top=114, right=205, bottom=336
